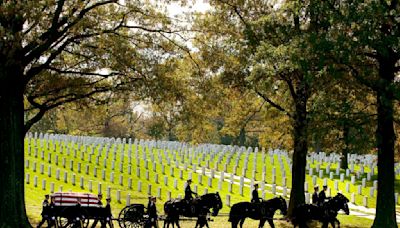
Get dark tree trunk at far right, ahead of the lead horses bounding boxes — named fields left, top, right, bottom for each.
left=372, top=58, right=397, bottom=228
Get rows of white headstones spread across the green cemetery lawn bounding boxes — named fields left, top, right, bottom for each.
left=26, top=134, right=400, bottom=206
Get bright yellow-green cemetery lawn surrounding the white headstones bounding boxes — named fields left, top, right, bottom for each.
left=25, top=139, right=400, bottom=227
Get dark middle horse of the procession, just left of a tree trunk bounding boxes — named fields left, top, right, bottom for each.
left=229, top=196, right=287, bottom=228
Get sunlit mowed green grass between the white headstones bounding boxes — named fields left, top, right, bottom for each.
left=25, top=139, right=398, bottom=227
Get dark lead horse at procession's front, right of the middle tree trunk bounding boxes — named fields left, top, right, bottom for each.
left=292, top=193, right=350, bottom=228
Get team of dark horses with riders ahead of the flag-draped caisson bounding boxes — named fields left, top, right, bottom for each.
left=164, top=180, right=350, bottom=228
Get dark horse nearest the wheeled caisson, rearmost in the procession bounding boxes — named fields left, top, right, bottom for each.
left=164, top=192, right=222, bottom=228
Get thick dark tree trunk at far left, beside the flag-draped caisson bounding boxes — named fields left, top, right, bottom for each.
left=0, top=11, right=31, bottom=224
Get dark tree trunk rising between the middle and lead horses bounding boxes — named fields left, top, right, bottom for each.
left=288, top=89, right=307, bottom=218
